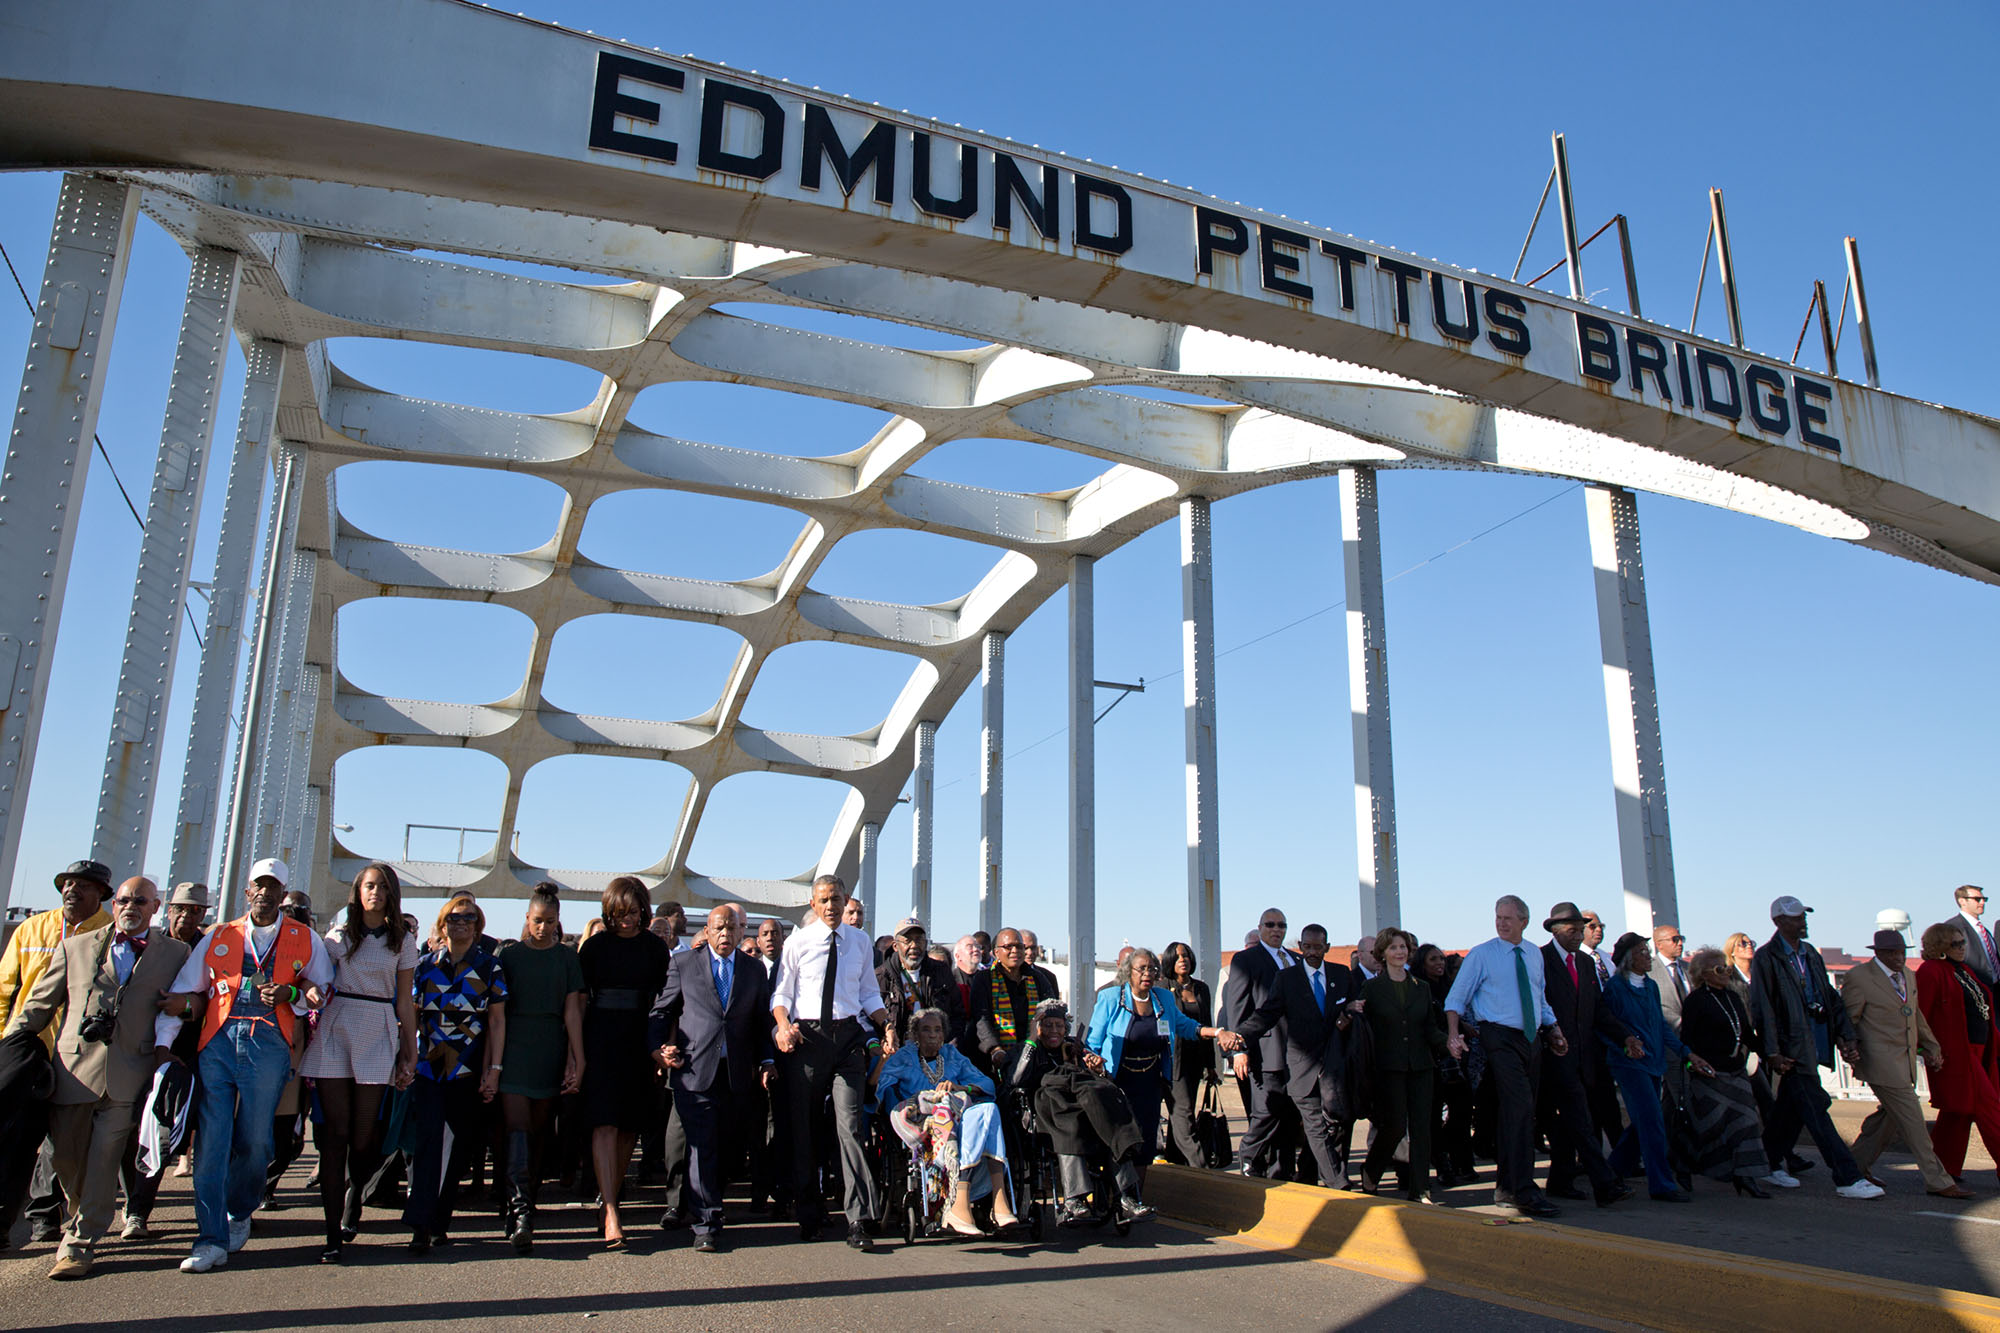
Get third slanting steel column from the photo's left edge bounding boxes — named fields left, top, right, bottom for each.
left=168, top=340, right=284, bottom=883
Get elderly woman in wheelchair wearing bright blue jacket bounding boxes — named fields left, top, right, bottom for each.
left=876, top=1009, right=1020, bottom=1235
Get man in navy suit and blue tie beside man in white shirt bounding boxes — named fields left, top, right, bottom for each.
left=646, top=903, right=774, bottom=1255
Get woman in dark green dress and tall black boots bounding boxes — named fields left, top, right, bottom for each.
left=500, top=881, right=584, bottom=1255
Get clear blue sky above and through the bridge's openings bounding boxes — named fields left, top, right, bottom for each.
left=0, top=0, right=2000, bottom=953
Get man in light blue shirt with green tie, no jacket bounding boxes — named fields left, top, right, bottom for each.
left=1444, top=893, right=1570, bottom=1217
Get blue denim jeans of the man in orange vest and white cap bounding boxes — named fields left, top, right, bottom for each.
left=194, top=1019, right=292, bottom=1249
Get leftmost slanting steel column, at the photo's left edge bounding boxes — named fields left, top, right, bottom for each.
left=0, top=176, right=138, bottom=907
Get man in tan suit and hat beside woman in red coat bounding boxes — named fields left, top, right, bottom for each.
left=1840, top=931, right=1972, bottom=1199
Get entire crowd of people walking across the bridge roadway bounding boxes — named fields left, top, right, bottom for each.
left=0, top=861, right=2000, bottom=1279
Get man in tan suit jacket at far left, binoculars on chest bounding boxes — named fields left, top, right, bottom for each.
left=8, top=879, right=188, bottom=1279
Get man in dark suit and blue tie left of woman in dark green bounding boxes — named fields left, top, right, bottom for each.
left=1236, top=925, right=1360, bottom=1189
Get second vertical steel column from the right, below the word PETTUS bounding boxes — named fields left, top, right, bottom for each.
left=1340, top=468, right=1402, bottom=935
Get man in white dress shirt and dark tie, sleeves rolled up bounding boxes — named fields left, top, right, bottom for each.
left=770, top=875, right=896, bottom=1251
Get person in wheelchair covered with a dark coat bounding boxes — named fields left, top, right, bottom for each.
left=1006, top=999, right=1154, bottom=1227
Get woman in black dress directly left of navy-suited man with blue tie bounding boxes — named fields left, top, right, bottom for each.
left=576, top=875, right=672, bottom=1249
